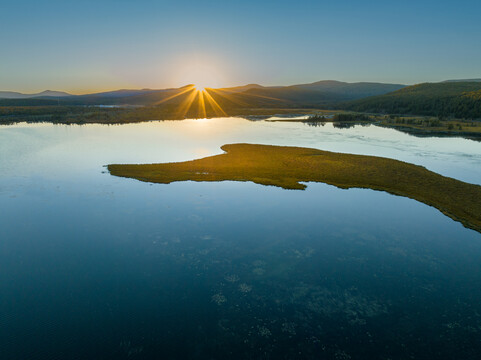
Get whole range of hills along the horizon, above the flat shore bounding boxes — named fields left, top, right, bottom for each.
left=0, top=80, right=481, bottom=119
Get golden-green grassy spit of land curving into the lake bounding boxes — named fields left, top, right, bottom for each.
left=108, top=144, right=481, bottom=232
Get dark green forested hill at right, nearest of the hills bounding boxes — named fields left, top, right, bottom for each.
left=331, top=81, right=481, bottom=119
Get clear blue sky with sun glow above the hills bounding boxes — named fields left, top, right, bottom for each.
left=0, top=0, right=481, bottom=94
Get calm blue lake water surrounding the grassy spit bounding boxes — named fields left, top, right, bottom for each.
left=0, top=119, right=481, bottom=360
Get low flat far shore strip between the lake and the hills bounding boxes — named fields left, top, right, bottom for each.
left=0, top=106, right=481, bottom=140
